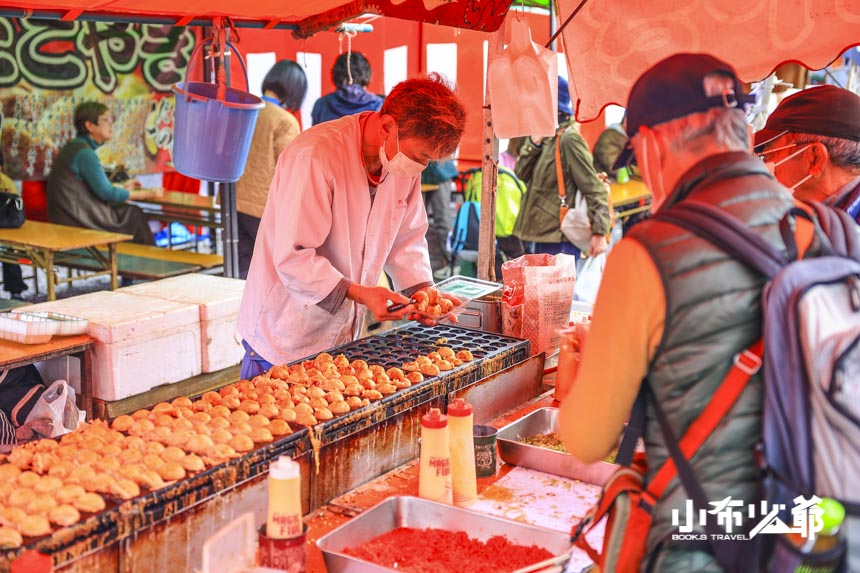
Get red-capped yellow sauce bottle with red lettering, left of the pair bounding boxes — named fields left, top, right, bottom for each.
left=418, top=408, right=453, bottom=504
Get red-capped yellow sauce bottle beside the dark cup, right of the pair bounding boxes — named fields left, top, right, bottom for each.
left=448, top=398, right=478, bottom=507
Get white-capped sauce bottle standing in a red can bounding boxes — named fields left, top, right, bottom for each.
left=266, top=456, right=304, bottom=539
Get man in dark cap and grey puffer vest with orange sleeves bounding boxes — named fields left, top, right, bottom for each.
left=560, top=54, right=818, bottom=573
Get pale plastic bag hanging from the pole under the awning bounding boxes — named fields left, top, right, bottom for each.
left=487, top=18, right=558, bottom=139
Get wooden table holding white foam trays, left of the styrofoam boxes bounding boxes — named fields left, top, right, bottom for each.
left=0, top=334, right=95, bottom=420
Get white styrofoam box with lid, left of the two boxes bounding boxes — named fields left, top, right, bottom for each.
left=16, top=291, right=201, bottom=401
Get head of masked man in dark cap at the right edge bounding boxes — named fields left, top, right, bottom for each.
left=755, top=86, right=860, bottom=222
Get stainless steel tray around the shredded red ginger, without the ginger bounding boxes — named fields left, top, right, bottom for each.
left=316, top=496, right=570, bottom=573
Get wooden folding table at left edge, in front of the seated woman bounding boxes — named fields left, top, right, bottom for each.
left=0, top=221, right=134, bottom=300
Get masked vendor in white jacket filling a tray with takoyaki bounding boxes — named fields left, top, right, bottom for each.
left=239, top=74, right=466, bottom=379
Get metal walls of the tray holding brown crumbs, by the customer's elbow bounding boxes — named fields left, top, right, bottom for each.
left=497, top=408, right=618, bottom=486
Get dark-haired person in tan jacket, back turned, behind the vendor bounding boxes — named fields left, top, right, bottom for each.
left=236, top=60, right=308, bottom=279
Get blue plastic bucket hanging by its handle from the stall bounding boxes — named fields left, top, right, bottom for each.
left=173, top=42, right=266, bottom=183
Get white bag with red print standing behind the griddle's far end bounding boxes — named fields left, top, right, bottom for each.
left=502, top=254, right=576, bottom=355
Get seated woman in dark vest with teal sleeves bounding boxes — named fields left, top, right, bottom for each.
left=47, top=102, right=155, bottom=245
